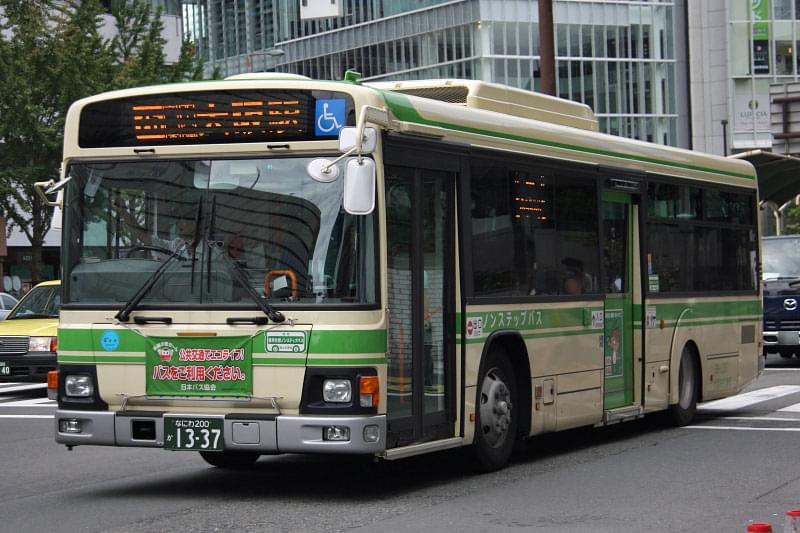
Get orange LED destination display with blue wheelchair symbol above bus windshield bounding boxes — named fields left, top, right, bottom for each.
left=78, top=90, right=355, bottom=148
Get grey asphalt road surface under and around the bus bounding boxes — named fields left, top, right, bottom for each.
left=0, top=357, right=800, bottom=533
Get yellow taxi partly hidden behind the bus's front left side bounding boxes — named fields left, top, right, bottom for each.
left=0, top=280, right=61, bottom=381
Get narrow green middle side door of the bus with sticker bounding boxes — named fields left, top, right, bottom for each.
left=601, top=192, right=634, bottom=411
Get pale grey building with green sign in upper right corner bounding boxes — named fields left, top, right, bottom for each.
left=689, top=0, right=800, bottom=154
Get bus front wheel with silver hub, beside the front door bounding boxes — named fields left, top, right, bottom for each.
left=472, top=346, right=519, bottom=472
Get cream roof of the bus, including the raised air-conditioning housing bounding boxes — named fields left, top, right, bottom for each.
left=64, top=73, right=757, bottom=188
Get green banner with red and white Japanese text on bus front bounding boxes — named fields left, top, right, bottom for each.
left=146, top=337, right=253, bottom=397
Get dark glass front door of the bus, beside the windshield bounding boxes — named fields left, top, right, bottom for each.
left=385, top=165, right=455, bottom=448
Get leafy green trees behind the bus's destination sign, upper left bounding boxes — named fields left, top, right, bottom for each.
left=0, top=0, right=209, bottom=281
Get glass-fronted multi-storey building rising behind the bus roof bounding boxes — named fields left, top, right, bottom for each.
left=181, top=0, right=689, bottom=146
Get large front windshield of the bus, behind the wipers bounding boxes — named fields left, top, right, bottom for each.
left=64, top=157, right=376, bottom=307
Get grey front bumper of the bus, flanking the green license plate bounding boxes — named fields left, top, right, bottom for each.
left=55, top=409, right=386, bottom=454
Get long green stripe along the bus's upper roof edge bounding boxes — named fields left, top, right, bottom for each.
left=383, top=91, right=755, bottom=180
